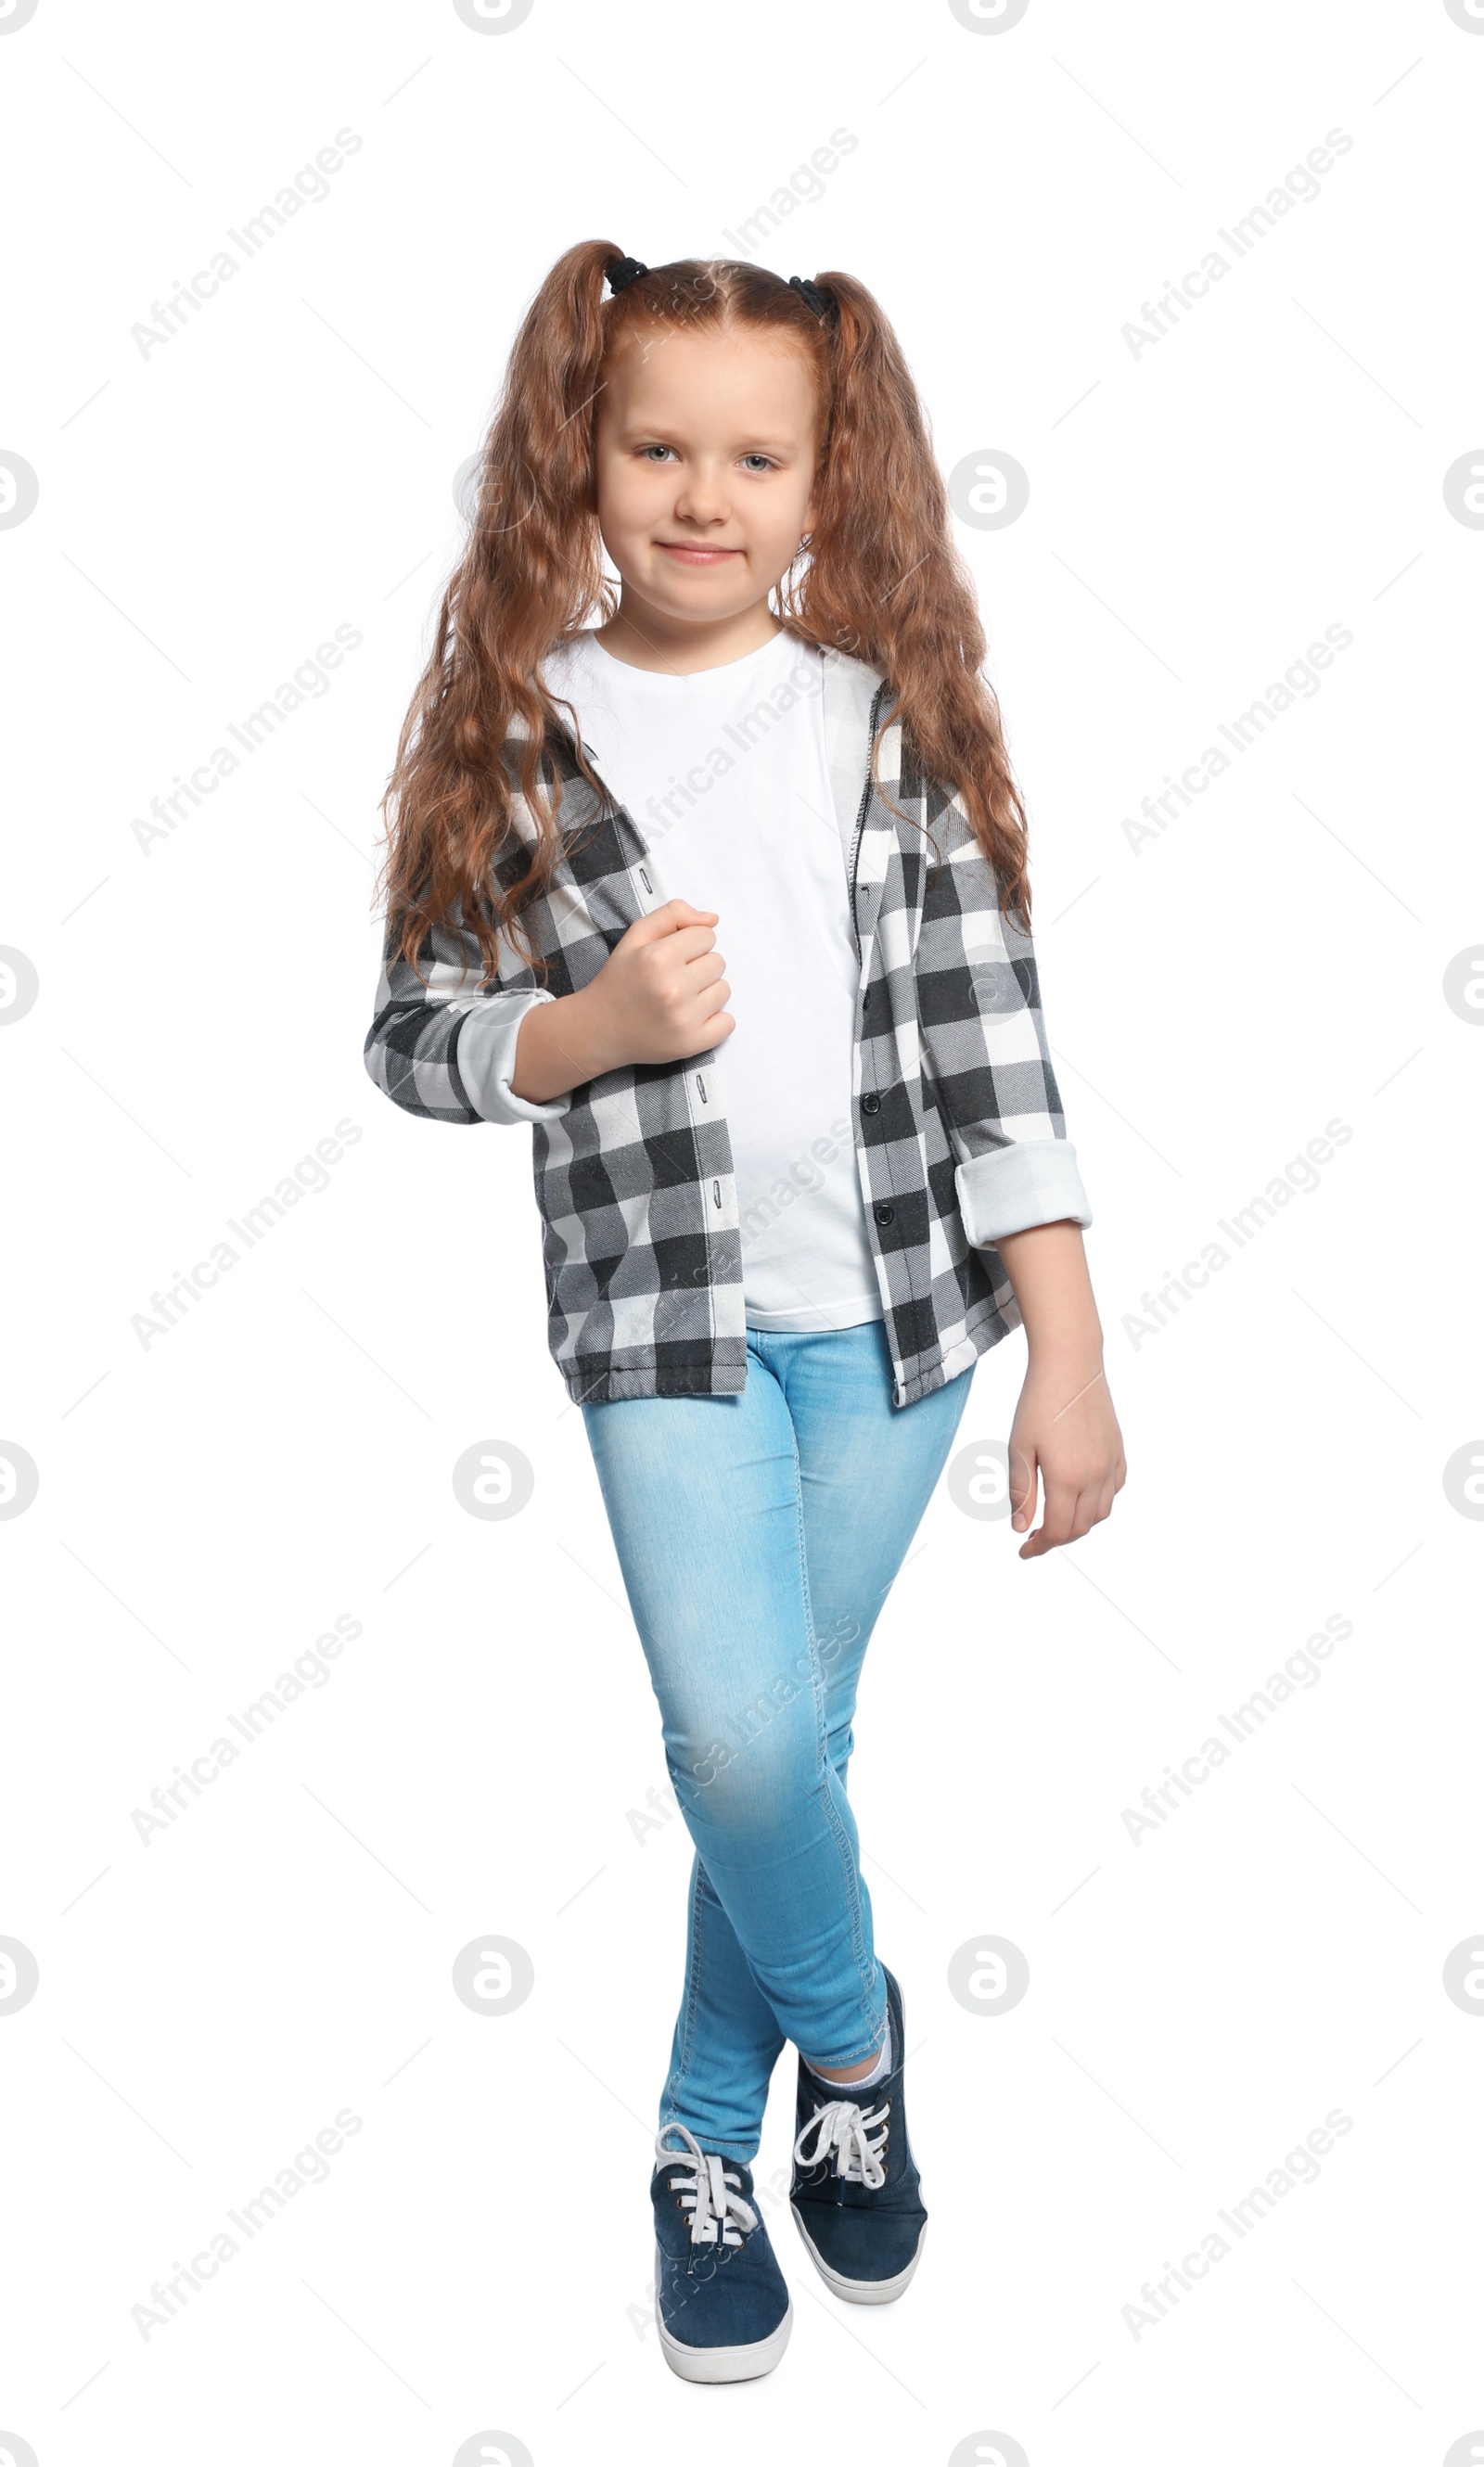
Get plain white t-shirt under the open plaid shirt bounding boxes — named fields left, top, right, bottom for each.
left=544, top=634, right=882, bottom=1330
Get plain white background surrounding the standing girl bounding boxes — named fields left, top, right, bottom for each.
left=0, top=0, right=1484, bottom=2467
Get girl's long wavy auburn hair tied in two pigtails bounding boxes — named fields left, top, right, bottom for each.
left=379, top=239, right=1030, bottom=979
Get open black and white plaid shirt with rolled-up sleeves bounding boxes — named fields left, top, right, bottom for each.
left=365, top=651, right=1092, bottom=1406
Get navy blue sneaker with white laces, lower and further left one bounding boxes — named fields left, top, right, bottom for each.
left=651, top=2124, right=794, bottom=2381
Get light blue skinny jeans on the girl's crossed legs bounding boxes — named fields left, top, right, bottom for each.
left=582, top=1320, right=974, bottom=2161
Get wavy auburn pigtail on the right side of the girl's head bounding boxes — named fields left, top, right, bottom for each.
left=787, top=274, right=1030, bottom=926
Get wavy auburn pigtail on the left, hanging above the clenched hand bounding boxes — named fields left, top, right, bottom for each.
left=379, top=239, right=621, bottom=979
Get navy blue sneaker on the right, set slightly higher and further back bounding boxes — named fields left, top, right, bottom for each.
left=788, top=1962, right=927, bottom=2304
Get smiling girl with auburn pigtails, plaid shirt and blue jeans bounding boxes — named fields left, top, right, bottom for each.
left=365, top=239, right=1124, bottom=2381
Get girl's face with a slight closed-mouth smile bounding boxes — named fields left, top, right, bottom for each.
left=596, top=330, right=816, bottom=629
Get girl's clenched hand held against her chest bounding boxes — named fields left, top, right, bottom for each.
left=574, top=901, right=737, bottom=1070
